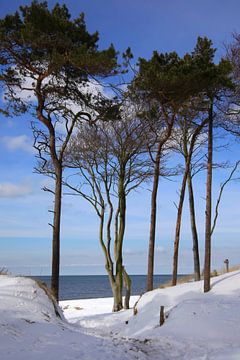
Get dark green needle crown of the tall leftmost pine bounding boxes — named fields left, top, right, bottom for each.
left=0, top=1, right=118, bottom=112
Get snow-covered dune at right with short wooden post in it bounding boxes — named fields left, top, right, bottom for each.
left=63, top=271, right=240, bottom=360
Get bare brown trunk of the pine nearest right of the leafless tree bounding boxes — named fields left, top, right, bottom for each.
left=147, top=144, right=162, bottom=291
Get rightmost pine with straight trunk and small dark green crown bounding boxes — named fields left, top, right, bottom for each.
left=189, top=37, right=233, bottom=292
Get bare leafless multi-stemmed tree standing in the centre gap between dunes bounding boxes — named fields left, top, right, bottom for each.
left=64, top=115, right=150, bottom=311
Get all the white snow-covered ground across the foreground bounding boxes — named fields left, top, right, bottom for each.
left=0, top=271, right=240, bottom=360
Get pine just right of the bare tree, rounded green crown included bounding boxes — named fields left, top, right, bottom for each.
left=133, top=52, right=208, bottom=290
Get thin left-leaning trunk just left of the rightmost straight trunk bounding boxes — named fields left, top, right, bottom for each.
left=187, top=171, right=201, bottom=281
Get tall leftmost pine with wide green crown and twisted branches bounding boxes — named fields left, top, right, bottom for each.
left=0, top=1, right=117, bottom=300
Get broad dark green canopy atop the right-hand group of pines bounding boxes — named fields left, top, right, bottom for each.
left=132, top=37, right=232, bottom=107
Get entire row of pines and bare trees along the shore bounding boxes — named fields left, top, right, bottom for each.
left=0, top=1, right=240, bottom=311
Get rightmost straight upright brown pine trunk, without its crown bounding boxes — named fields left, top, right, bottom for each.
left=204, top=103, right=213, bottom=292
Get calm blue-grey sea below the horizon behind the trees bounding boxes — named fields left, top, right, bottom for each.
left=32, top=275, right=181, bottom=300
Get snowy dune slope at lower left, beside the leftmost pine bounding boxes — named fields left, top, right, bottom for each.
left=0, top=276, right=146, bottom=360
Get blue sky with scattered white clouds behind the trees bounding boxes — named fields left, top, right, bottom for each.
left=0, top=0, right=240, bottom=275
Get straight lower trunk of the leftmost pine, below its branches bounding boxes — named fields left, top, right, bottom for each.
left=51, top=165, right=62, bottom=301
